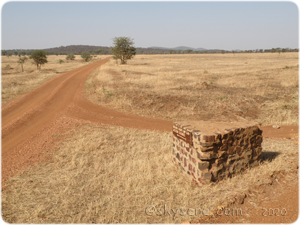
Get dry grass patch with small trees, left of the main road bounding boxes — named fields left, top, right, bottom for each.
left=0, top=55, right=101, bottom=106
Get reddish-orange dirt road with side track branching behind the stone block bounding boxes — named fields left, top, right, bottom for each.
left=0, top=58, right=300, bottom=224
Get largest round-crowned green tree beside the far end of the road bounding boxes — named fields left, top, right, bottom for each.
left=110, top=37, right=136, bottom=64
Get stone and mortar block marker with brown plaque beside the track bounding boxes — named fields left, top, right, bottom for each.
left=172, top=121, right=263, bottom=185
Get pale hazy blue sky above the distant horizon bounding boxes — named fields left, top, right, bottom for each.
left=0, top=0, right=300, bottom=50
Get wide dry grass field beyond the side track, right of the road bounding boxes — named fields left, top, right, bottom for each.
left=86, top=53, right=300, bottom=124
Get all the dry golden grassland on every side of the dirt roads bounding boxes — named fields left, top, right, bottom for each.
left=0, top=53, right=300, bottom=224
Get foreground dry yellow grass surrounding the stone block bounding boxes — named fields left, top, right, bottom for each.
left=0, top=125, right=299, bottom=225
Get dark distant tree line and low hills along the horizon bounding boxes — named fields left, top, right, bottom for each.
left=0, top=45, right=300, bottom=56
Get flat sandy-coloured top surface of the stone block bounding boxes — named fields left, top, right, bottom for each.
left=174, top=121, right=259, bottom=134
